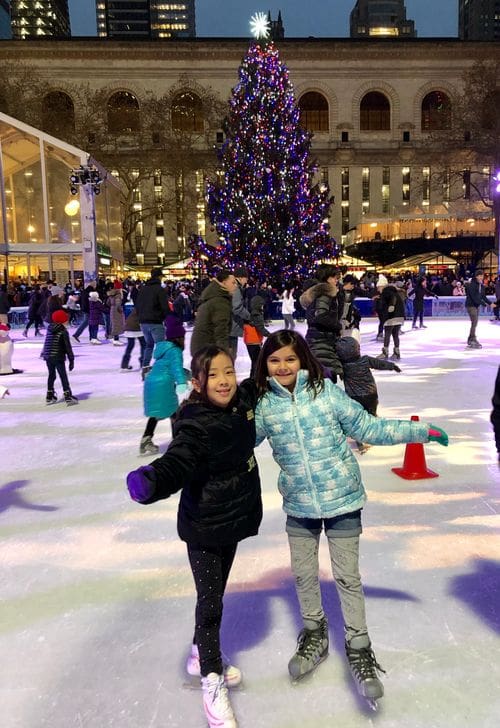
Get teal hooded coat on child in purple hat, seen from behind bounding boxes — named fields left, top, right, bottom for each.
left=144, top=341, right=186, bottom=420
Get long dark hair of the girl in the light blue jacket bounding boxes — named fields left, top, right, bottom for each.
left=255, top=329, right=325, bottom=397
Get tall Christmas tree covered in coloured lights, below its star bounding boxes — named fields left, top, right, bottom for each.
left=203, top=42, right=337, bottom=279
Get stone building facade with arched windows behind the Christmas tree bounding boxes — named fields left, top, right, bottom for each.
left=0, top=38, right=500, bottom=265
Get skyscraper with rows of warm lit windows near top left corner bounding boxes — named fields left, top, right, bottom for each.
left=11, top=0, right=71, bottom=40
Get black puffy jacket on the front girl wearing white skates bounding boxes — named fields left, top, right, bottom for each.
left=147, top=380, right=262, bottom=546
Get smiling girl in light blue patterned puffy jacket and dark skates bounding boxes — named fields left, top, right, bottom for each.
left=255, top=331, right=448, bottom=702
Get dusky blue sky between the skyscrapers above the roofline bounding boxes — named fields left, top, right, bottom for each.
left=69, top=0, right=458, bottom=38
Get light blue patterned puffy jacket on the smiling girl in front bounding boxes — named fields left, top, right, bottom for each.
left=255, top=370, right=429, bottom=518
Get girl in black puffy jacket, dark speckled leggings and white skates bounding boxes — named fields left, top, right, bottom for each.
left=127, top=346, right=262, bottom=728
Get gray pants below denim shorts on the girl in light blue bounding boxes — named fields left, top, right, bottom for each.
left=288, top=529, right=368, bottom=640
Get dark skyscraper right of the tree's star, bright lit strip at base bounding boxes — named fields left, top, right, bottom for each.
left=350, top=0, right=417, bottom=38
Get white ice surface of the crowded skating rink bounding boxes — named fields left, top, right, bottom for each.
left=0, top=318, right=500, bottom=728
